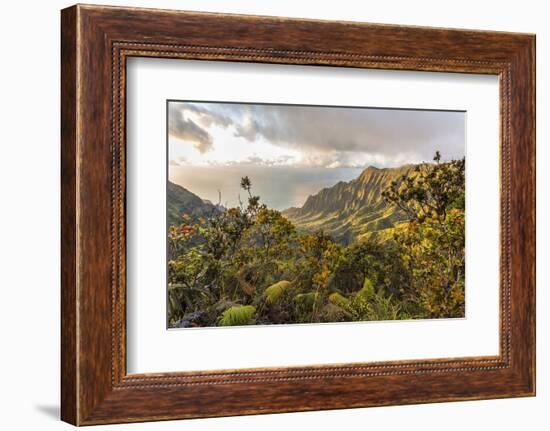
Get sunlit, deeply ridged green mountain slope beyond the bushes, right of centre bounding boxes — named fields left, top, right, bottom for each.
left=283, top=165, right=414, bottom=244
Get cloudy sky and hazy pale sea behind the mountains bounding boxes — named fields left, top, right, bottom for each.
left=168, top=101, right=465, bottom=209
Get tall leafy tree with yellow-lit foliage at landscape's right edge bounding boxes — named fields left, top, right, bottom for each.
left=383, top=152, right=465, bottom=317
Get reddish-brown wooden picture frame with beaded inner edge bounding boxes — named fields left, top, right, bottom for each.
left=61, top=5, right=535, bottom=425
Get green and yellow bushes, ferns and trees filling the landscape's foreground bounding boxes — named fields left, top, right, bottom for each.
left=168, top=153, right=465, bottom=327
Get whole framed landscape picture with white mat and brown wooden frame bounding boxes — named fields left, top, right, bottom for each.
left=61, top=5, right=535, bottom=425
